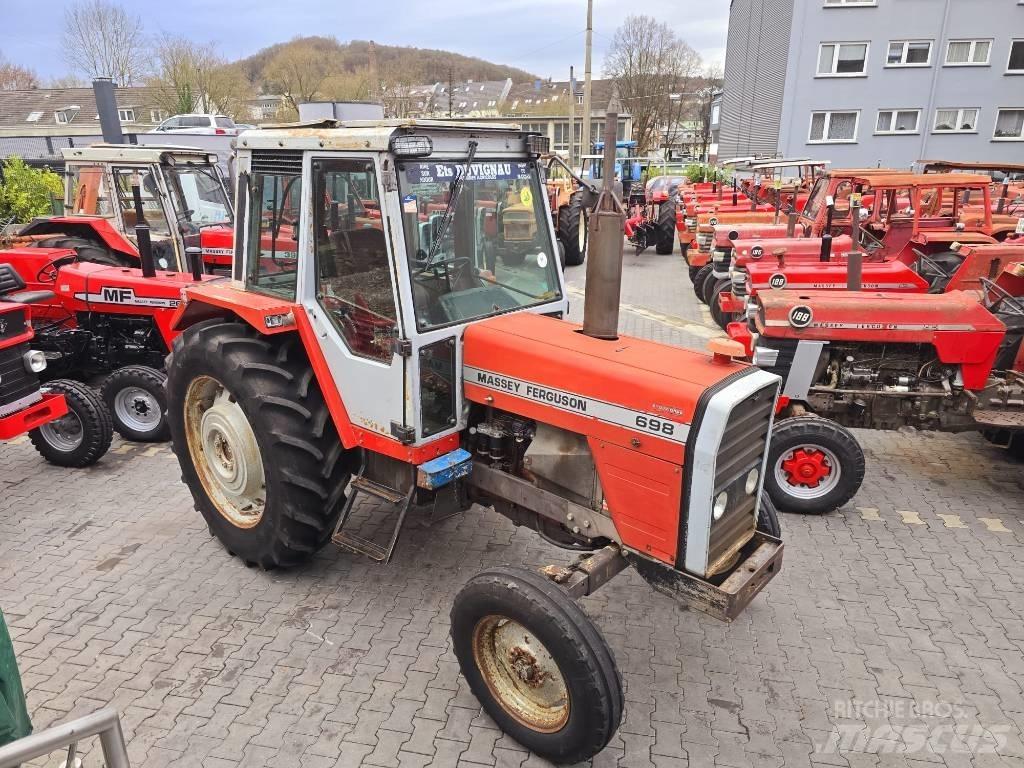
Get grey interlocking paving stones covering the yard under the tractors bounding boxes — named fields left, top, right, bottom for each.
left=0, top=247, right=1024, bottom=768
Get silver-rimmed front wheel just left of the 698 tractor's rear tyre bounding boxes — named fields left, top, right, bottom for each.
left=101, top=366, right=170, bottom=442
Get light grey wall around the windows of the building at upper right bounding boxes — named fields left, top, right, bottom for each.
left=774, top=0, right=1024, bottom=168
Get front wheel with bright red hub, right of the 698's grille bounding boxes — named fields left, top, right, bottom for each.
left=765, top=416, right=864, bottom=514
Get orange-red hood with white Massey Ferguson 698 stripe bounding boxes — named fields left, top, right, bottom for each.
left=463, top=312, right=752, bottom=464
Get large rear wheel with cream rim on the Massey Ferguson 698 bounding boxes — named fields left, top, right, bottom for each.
left=167, top=319, right=351, bottom=568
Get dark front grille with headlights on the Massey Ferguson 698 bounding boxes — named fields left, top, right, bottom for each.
left=708, top=383, right=777, bottom=575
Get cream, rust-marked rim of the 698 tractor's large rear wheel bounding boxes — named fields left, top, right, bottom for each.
left=184, top=376, right=266, bottom=528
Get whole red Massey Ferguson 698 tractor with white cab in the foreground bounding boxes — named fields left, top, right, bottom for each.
left=161, top=120, right=781, bottom=762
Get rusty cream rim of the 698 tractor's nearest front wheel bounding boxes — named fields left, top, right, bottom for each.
left=473, top=615, right=569, bottom=733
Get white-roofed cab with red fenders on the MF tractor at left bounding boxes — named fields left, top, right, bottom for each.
left=19, top=144, right=233, bottom=271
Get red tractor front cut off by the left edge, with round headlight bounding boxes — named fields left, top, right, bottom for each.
left=0, top=264, right=113, bottom=467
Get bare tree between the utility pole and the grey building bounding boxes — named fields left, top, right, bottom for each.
left=604, top=15, right=700, bottom=152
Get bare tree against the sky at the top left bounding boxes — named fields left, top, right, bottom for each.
left=61, top=0, right=147, bottom=86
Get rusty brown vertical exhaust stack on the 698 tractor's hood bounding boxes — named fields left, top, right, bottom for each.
left=583, top=112, right=626, bottom=340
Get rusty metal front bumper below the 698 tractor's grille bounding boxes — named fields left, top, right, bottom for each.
left=625, top=531, right=783, bottom=622
